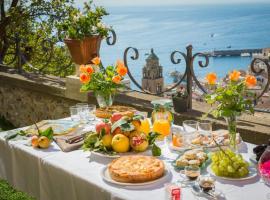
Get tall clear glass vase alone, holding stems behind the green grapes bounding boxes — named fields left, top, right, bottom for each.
left=225, top=115, right=238, bottom=152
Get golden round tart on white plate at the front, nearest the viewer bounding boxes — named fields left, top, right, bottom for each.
left=108, top=155, right=165, bottom=183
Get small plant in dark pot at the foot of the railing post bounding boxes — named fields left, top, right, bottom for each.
left=172, top=87, right=188, bottom=113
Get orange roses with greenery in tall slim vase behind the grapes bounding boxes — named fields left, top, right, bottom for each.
left=205, top=70, right=257, bottom=151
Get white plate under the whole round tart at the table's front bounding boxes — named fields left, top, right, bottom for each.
left=101, top=166, right=171, bottom=187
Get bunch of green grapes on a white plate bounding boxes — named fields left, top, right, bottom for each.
left=211, top=149, right=249, bottom=178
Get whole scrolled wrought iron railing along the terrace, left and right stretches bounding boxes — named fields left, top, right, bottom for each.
left=0, top=30, right=270, bottom=109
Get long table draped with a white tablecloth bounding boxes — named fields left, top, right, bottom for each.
left=0, top=120, right=270, bottom=200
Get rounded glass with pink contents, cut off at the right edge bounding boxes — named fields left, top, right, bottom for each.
left=258, top=146, right=270, bottom=186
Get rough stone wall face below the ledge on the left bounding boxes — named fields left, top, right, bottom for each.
left=0, top=85, right=74, bottom=127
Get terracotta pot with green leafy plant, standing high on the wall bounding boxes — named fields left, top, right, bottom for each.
left=59, top=1, right=110, bottom=75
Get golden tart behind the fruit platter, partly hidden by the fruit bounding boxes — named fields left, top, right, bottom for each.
left=96, top=106, right=137, bottom=119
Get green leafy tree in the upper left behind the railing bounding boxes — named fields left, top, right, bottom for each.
left=0, top=0, right=80, bottom=76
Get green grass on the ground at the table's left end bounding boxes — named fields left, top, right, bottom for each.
left=0, top=116, right=34, bottom=200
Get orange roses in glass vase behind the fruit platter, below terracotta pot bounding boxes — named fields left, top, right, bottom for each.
left=80, top=57, right=127, bottom=108
